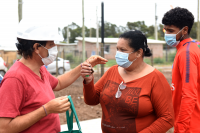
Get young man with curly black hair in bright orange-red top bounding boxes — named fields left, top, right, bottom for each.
left=162, top=7, right=200, bottom=133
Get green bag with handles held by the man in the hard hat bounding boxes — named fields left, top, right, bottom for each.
left=60, top=96, right=82, bottom=133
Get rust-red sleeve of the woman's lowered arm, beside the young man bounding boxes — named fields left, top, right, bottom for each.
left=140, top=72, right=174, bottom=133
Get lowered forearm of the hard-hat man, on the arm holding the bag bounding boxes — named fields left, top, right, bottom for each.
left=0, top=107, right=46, bottom=133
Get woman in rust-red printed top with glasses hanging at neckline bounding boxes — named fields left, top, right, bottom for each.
left=81, top=31, right=174, bottom=133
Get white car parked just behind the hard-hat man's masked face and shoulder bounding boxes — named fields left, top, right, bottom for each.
left=45, top=57, right=70, bottom=75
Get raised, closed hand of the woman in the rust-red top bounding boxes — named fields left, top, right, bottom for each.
left=81, top=62, right=93, bottom=84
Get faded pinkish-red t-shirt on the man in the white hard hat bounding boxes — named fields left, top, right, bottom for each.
left=0, top=61, right=60, bottom=133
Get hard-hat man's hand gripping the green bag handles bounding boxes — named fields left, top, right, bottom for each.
left=44, top=96, right=71, bottom=114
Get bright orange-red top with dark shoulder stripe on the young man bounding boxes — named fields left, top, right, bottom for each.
left=171, top=38, right=200, bottom=133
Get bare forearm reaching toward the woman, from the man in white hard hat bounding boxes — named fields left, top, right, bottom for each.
left=54, top=65, right=81, bottom=91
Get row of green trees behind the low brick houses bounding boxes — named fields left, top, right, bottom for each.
left=62, top=21, right=167, bottom=43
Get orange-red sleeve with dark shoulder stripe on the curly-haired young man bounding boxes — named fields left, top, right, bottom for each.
left=174, top=49, right=198, bottom=133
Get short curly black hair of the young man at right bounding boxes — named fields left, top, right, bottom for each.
left=162, top=7, right=194, bottom=34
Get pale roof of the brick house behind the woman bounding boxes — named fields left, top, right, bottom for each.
left=76, top=37, right=166, bottom=44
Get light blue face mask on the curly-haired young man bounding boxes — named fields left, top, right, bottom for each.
left=165, top=29, right=184, bottom=47
